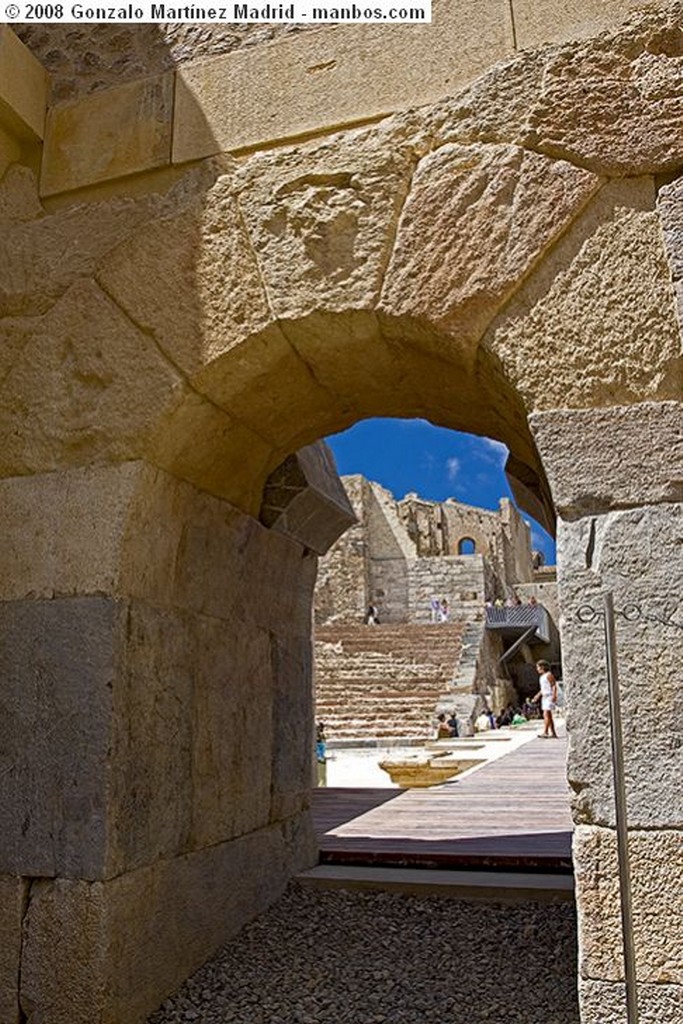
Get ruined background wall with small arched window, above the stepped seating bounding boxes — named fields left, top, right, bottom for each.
left=315, top=476, right=532, bottom=624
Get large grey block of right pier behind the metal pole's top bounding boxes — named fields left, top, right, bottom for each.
left=558, top=504, right=683, bottom=828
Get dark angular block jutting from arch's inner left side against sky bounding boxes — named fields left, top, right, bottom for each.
left=260, top=441, right=355, bottom=555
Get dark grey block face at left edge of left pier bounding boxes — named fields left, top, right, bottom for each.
left=0, top=597, right=114, bottom=878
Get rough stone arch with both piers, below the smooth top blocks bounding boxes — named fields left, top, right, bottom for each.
left=0, top=5, right=683, bottom=1024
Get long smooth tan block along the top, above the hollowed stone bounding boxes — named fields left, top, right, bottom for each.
left=173, top=0, right=514, bottom=163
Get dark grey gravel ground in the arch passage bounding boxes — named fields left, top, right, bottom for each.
left=148, top=884, right=579, bottom=1024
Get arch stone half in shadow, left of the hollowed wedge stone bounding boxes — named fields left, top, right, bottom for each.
left=97, top=170, right=270, bottom=375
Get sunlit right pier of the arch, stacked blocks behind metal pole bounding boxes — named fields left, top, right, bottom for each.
left=531, top=401, right=683, bottom=1024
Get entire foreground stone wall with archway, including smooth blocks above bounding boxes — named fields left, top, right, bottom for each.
left=0, top=0, right=683, bottom=1024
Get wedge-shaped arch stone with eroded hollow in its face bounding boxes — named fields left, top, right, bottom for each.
left=236, top=130, right=415, bottom=318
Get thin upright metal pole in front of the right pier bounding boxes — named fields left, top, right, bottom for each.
left=603, top=591, right=638, bottom=1024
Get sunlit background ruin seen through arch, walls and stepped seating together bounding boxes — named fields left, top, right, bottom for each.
left=313, top=476, right=561, bottom=738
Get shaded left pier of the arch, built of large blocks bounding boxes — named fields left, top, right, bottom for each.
left=0, top=462, right=323, bottom=1024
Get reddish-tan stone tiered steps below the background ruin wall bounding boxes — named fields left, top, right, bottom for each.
left=314, top=623, right=465, bottom=739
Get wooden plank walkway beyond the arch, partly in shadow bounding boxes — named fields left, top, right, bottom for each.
left=312, top=738, right=572, bottom=872
